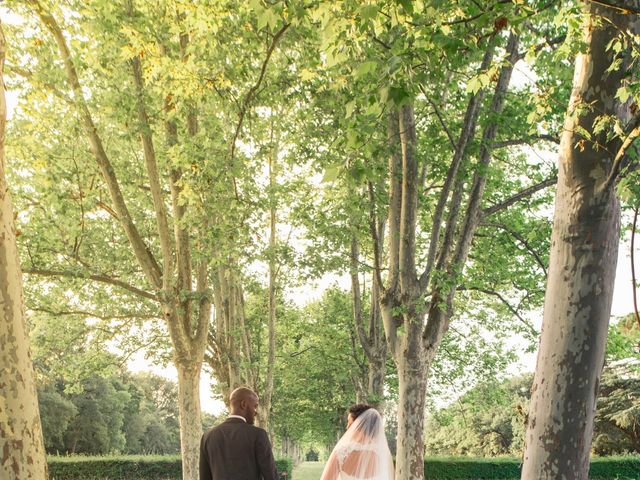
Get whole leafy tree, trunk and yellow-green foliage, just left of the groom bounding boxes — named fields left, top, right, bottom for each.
left=5, top=1, right=300, bottom=478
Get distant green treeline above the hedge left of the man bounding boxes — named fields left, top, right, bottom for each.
left=38, top=374, right=220, bottom=455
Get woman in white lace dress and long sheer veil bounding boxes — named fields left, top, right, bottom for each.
left=320, top=404, right=394, bottom=480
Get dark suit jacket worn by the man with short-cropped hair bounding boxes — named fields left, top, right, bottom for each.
left=200, top=418, right=277, bottom=480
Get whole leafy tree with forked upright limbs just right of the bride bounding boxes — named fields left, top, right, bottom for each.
left=308, top=2, right=564, bottom=479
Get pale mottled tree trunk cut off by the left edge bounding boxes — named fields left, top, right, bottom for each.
left=0, top=22, right=47, bottom=480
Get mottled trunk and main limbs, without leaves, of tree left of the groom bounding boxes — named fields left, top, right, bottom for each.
left=11, top=0, right=210, bottom=479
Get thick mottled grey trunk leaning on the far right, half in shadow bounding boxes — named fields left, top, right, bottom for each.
left=522, top=2, right=638, bottom=480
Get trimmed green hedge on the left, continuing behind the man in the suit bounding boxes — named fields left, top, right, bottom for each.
left=47, top=455, right=293, bottom=480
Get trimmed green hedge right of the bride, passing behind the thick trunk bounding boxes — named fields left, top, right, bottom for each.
left=424, top=456, right=640, bottom=480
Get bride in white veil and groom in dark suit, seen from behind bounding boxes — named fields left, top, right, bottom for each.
left=200, top=387, right=394, bottom=480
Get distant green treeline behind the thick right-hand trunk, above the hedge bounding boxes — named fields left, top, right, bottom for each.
left=426, top=363, right=640, bottom=457
